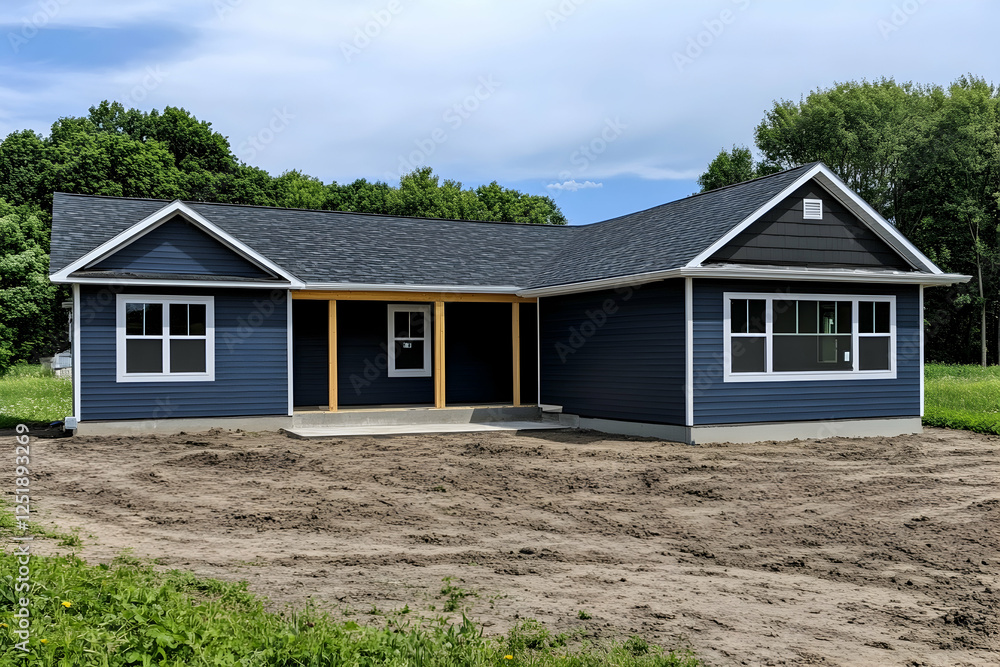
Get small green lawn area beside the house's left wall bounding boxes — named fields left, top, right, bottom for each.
left=0, top=364, right=73, bottom=428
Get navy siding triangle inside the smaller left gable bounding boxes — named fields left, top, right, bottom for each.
left=87, top=216, right=273, bottom=279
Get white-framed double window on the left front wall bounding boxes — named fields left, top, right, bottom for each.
left=115, top=294, right=215, bottom=382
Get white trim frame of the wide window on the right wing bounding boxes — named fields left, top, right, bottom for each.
left=722, top=292, right=896, bottom=382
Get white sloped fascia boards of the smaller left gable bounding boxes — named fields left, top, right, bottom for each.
left=49, top=199, right=302, bottom=288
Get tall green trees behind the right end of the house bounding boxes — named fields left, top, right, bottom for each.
left=698, top=75, right=1000, bottom=366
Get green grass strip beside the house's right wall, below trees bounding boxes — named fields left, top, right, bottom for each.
left=924, top=364, right=1000, bottom=434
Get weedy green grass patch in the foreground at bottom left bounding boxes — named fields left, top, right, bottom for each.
left=0, top=555, right=701, bottom=667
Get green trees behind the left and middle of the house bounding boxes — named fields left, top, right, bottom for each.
left=0, top=101, right=566, bottom=373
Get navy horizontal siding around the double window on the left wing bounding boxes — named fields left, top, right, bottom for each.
left=80, top=286, right=288, bottom=421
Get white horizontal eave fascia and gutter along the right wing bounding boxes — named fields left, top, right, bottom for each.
left=517, top=266, right=971, bottom=297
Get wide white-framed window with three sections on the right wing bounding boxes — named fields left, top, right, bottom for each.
left=723, top=292, right=896, bottom=382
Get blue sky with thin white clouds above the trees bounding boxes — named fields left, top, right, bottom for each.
left=0, top=0, right=1000, bottom=223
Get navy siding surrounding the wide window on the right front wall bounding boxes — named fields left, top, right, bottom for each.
left=694, top=280, right=921, bottom=425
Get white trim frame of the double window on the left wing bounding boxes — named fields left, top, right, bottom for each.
left=115, top=294, right=215, bottom=382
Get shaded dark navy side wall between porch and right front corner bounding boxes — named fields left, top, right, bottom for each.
left=540, top=280, right=684, bottom=424
